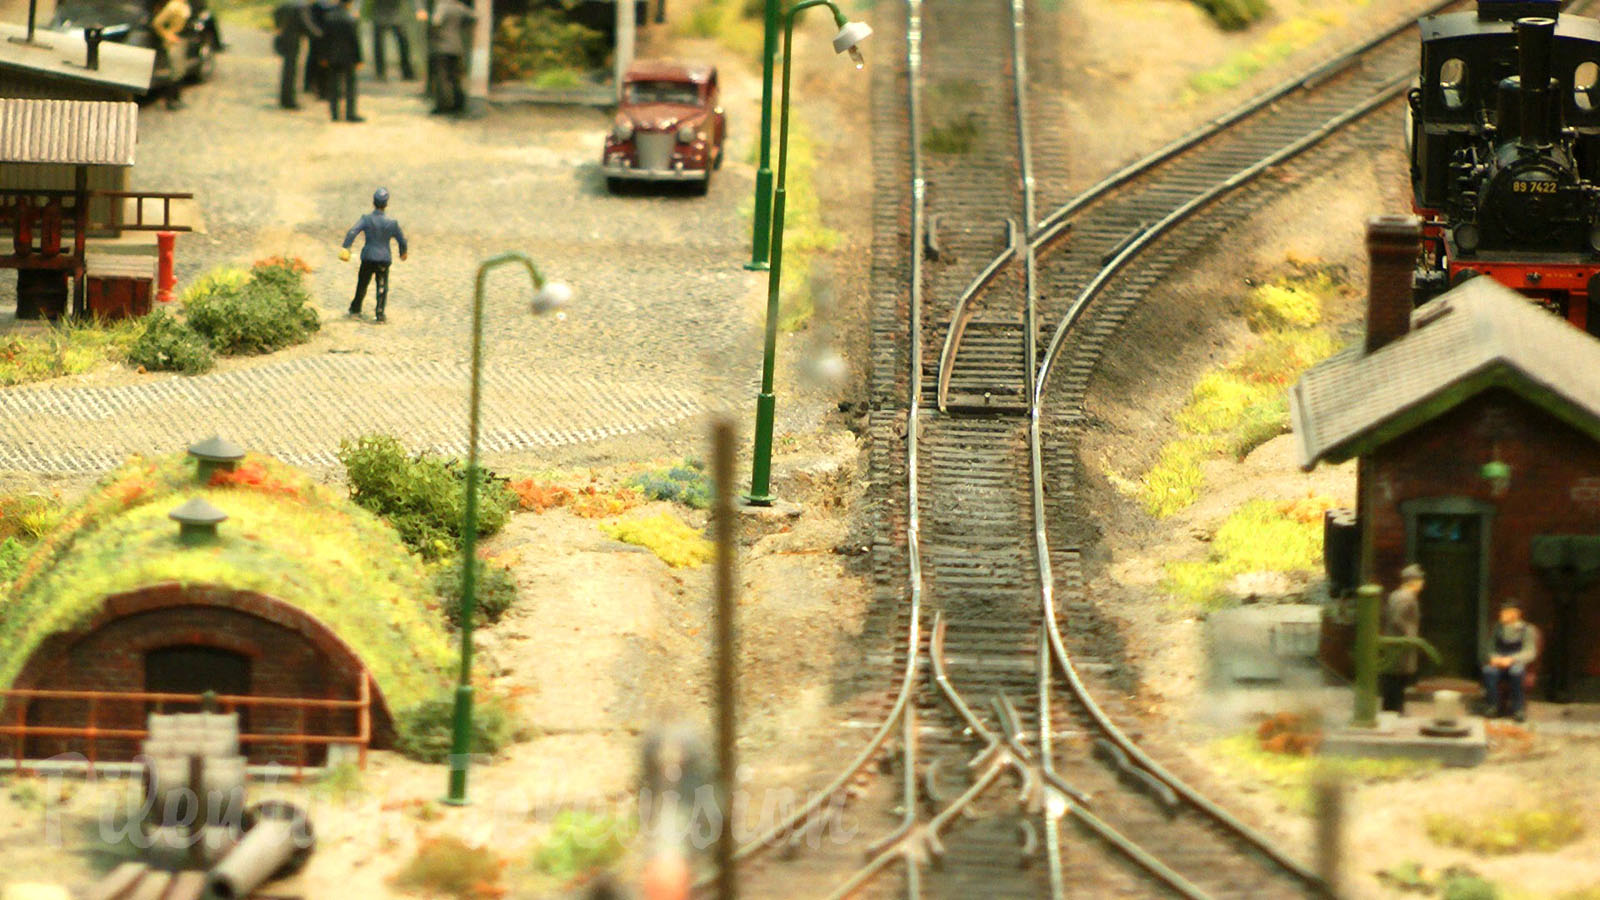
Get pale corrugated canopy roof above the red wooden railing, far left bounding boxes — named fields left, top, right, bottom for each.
left=0, top=98, right=139, bottom=165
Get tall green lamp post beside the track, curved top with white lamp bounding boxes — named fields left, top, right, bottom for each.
left=746, top=0, right=872, bottom=506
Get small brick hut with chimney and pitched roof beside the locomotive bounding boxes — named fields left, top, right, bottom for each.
left=1290, top=218, right=1600, bottom=698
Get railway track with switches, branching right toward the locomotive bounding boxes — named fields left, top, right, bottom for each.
left=720, top=0, right=1504, bottom=898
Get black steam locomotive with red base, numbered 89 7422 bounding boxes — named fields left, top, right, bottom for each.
left=1406, top=0, right=1600, bottom=335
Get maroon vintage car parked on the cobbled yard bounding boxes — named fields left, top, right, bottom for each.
left=600, top=61, right=728, bottom=194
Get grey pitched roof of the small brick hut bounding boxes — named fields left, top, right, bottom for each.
left=1290, top=277, right=1600, bottom=469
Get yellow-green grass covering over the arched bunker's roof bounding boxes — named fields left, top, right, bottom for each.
left=0, top=455, right=451, bottom=716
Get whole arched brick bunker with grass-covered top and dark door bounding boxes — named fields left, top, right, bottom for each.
left=0, top=456, right=451, bottom=764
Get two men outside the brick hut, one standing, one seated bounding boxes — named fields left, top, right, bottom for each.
left=1379, top=564, right=1539, bottom=722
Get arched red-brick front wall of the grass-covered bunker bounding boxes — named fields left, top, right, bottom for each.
left=14, top=583, right=395, bottom=764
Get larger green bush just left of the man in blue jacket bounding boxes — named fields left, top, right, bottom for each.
left=184, top=264, right=322, bottom=356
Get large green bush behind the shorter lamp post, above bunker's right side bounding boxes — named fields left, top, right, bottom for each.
left=339, top=434, right=517, bottom=560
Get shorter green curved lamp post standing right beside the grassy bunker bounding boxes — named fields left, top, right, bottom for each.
left=445, top=251, right=573, bottom=806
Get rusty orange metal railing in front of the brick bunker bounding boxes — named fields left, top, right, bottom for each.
left=0, top=669, right=373, bottom=781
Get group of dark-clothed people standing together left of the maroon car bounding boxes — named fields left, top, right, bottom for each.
left=268, top=0, right=477, bottom=122
